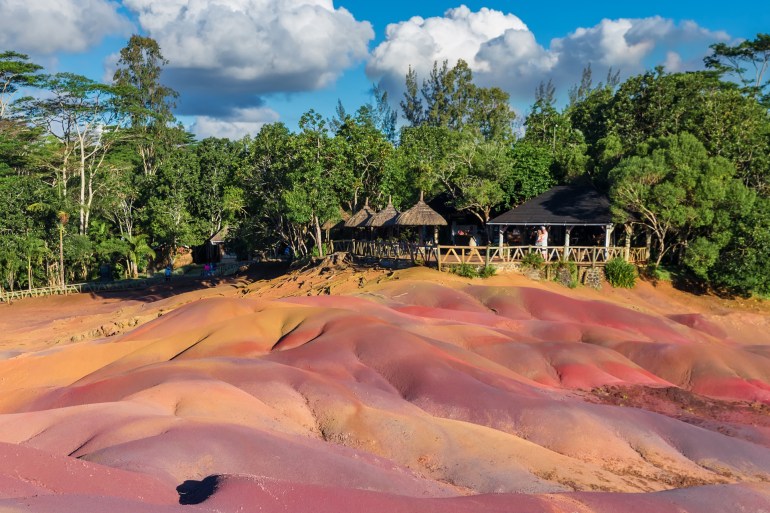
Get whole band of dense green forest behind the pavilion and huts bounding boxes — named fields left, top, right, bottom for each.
left=0, top=34, right=770, bottom=294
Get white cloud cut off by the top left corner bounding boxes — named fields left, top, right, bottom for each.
left=0, top=0, right=131, bottom=55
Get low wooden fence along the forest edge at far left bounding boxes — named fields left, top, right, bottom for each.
left=0, top=263, right=245, bottom=303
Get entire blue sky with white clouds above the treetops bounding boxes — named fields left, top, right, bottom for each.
left=0, top=0, right=770, bottom=138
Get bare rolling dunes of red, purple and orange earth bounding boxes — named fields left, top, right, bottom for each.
left=0, top=262, right=770, bottom=513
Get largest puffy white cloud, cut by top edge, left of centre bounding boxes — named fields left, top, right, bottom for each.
left=123, top=0, right=374, bottom=94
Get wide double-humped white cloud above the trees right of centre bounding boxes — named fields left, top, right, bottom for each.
left=366, top=6, right=728, bottom=108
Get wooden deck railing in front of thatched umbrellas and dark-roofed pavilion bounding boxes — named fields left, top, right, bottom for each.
left=332, top=239, right=648, bottom=270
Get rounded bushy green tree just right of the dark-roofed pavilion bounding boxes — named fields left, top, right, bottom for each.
left=610, top=133, right=743, bottom=268
